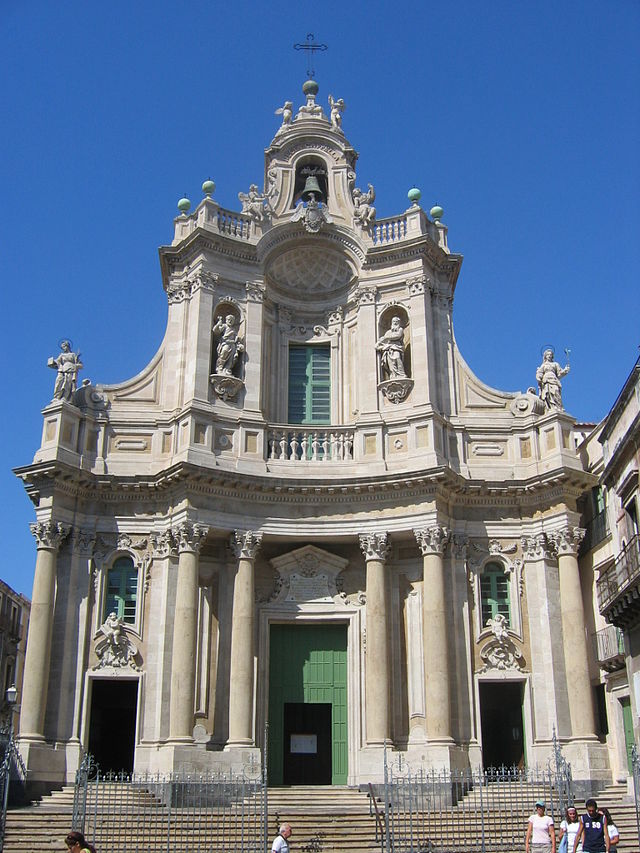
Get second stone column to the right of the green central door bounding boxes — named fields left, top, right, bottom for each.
left=413, top=524, right=452, bottom=743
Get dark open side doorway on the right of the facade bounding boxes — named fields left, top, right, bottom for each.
left=480, top=681, right=525, bottom=768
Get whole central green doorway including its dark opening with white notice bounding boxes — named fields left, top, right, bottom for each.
left=268, top=625, right=347, bottom=785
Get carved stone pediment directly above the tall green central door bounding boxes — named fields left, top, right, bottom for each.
left=270, top=545, right=349, bottom=606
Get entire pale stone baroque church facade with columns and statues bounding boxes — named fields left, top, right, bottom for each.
left=17, top=81, right=611, bottom=786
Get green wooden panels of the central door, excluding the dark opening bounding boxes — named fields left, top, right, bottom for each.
left=268, top=625, right=347, bottom=785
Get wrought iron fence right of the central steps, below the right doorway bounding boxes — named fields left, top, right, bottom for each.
left=376, top=735, right=573, bottom=853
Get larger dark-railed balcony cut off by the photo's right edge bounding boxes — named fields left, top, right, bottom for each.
left=596, top=536, right=640, bottom=628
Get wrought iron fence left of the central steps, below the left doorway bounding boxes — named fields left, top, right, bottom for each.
left=72, top=755, right=268, bottom=853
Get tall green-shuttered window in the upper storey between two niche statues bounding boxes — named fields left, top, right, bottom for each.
left=288, top=345, right=331, bottom=424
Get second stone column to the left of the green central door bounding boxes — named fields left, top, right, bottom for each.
left=169, top=522, right=209, bottom=743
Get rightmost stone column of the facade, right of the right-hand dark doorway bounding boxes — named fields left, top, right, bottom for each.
left=554, top=525, right=595, bottom=739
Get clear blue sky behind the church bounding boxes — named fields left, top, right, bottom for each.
left=0, top=0, right=640, bottom=595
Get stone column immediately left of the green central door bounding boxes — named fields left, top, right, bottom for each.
left=225, top=530, right=262, bottom=749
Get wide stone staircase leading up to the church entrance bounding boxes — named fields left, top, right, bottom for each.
left=4, top=783, right=639, bottom=853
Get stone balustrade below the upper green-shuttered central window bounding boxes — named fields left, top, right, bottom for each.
left=269, top=426, right=353, bottom=462
